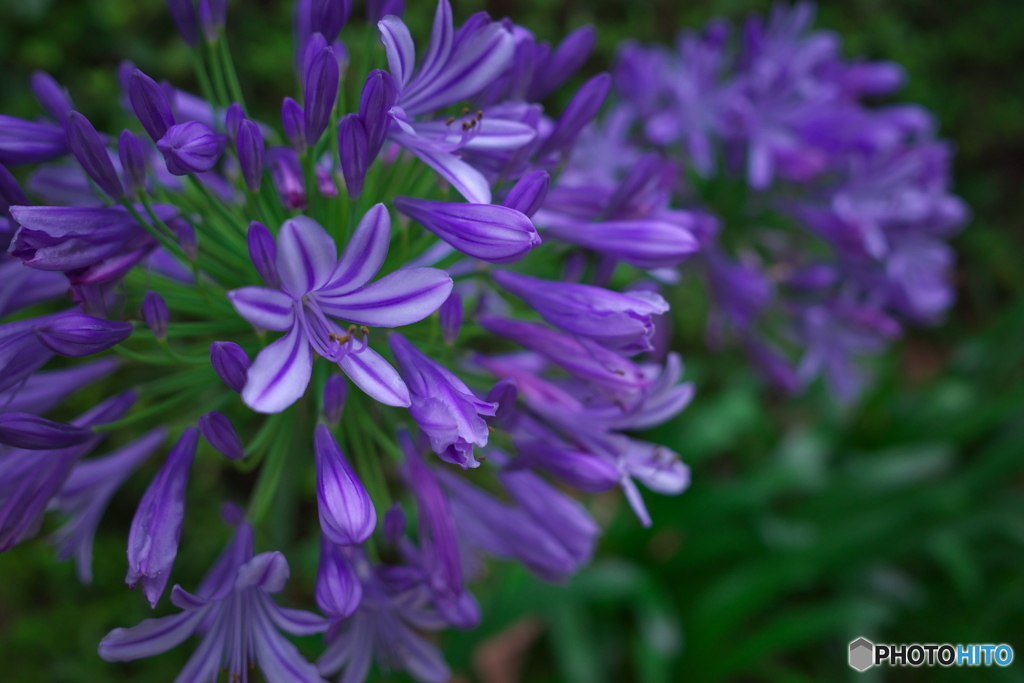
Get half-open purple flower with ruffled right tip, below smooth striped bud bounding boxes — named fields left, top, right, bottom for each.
left=494, top=270, right=669, bottom=354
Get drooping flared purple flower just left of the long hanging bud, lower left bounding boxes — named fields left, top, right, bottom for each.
left=50, top=427, right=167, bottom=584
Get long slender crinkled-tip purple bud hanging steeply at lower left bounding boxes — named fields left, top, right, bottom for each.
left=125, top=427, right=199, bottom=607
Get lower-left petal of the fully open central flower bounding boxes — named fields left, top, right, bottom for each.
left=242, top=326, right=313, bottom=413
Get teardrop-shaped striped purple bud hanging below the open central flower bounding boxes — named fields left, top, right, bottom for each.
left=313, top=425, right=377, bottom=546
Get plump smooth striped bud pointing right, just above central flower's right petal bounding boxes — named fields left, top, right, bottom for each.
left=394, top=197, right=541, bottom=263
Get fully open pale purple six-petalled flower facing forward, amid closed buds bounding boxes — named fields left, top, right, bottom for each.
left=228, top=204, right=452, bottom=413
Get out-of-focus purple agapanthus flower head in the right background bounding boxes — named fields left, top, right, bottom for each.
left=569, top=3, right=967, bottom=399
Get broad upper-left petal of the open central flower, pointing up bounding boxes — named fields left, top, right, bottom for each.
left=278, top=216, right=338, bottom=299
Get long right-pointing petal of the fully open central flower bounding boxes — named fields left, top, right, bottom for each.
left=316, top=268, right=452, bottom=328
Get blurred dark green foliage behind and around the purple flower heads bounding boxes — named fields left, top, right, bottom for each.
left=0, top=0, right=1024, bottom=683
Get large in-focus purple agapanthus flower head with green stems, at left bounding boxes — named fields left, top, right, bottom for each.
left=0, top=0, right=696, bottom=682
